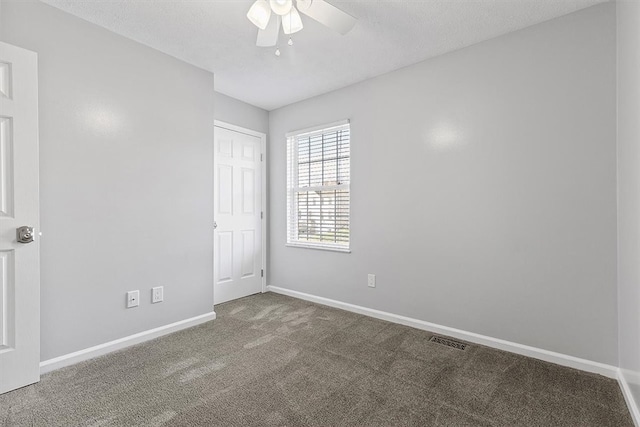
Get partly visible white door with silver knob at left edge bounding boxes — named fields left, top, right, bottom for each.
left=0, top=42, right=40, bottom=393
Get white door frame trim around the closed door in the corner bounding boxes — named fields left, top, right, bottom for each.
left=212, top=120, right=268, bottom=305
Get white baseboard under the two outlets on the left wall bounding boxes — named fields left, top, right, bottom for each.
left=40, top=311, right=216, bottom=374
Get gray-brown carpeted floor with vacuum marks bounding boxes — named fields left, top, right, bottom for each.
left=0, top=293, right=633, bottom=427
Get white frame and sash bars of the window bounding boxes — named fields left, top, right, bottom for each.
left=285, top=120, right=352, bottom=253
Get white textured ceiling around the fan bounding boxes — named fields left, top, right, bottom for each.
left=43, top=0, right=606, bottom=110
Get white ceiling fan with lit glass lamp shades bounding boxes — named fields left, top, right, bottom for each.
left=247, top=0, right=356, bottom=49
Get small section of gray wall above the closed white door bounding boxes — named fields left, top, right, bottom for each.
left=215, top=92, right=269, bottom=134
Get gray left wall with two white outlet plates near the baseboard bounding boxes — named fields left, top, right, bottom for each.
left=0, top=1, right=214, bottom=360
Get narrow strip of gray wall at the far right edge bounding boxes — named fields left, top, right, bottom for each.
left=617, top=0, right=640, bottom=414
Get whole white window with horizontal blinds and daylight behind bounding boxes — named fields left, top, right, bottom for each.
left=287, top=121, right=351, bottom=251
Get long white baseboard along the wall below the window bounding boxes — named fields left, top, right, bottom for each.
left=267, top=286, right=616, bottom=380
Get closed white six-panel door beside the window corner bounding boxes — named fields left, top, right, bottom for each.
left=213, top=126, right=263, bottom=304
